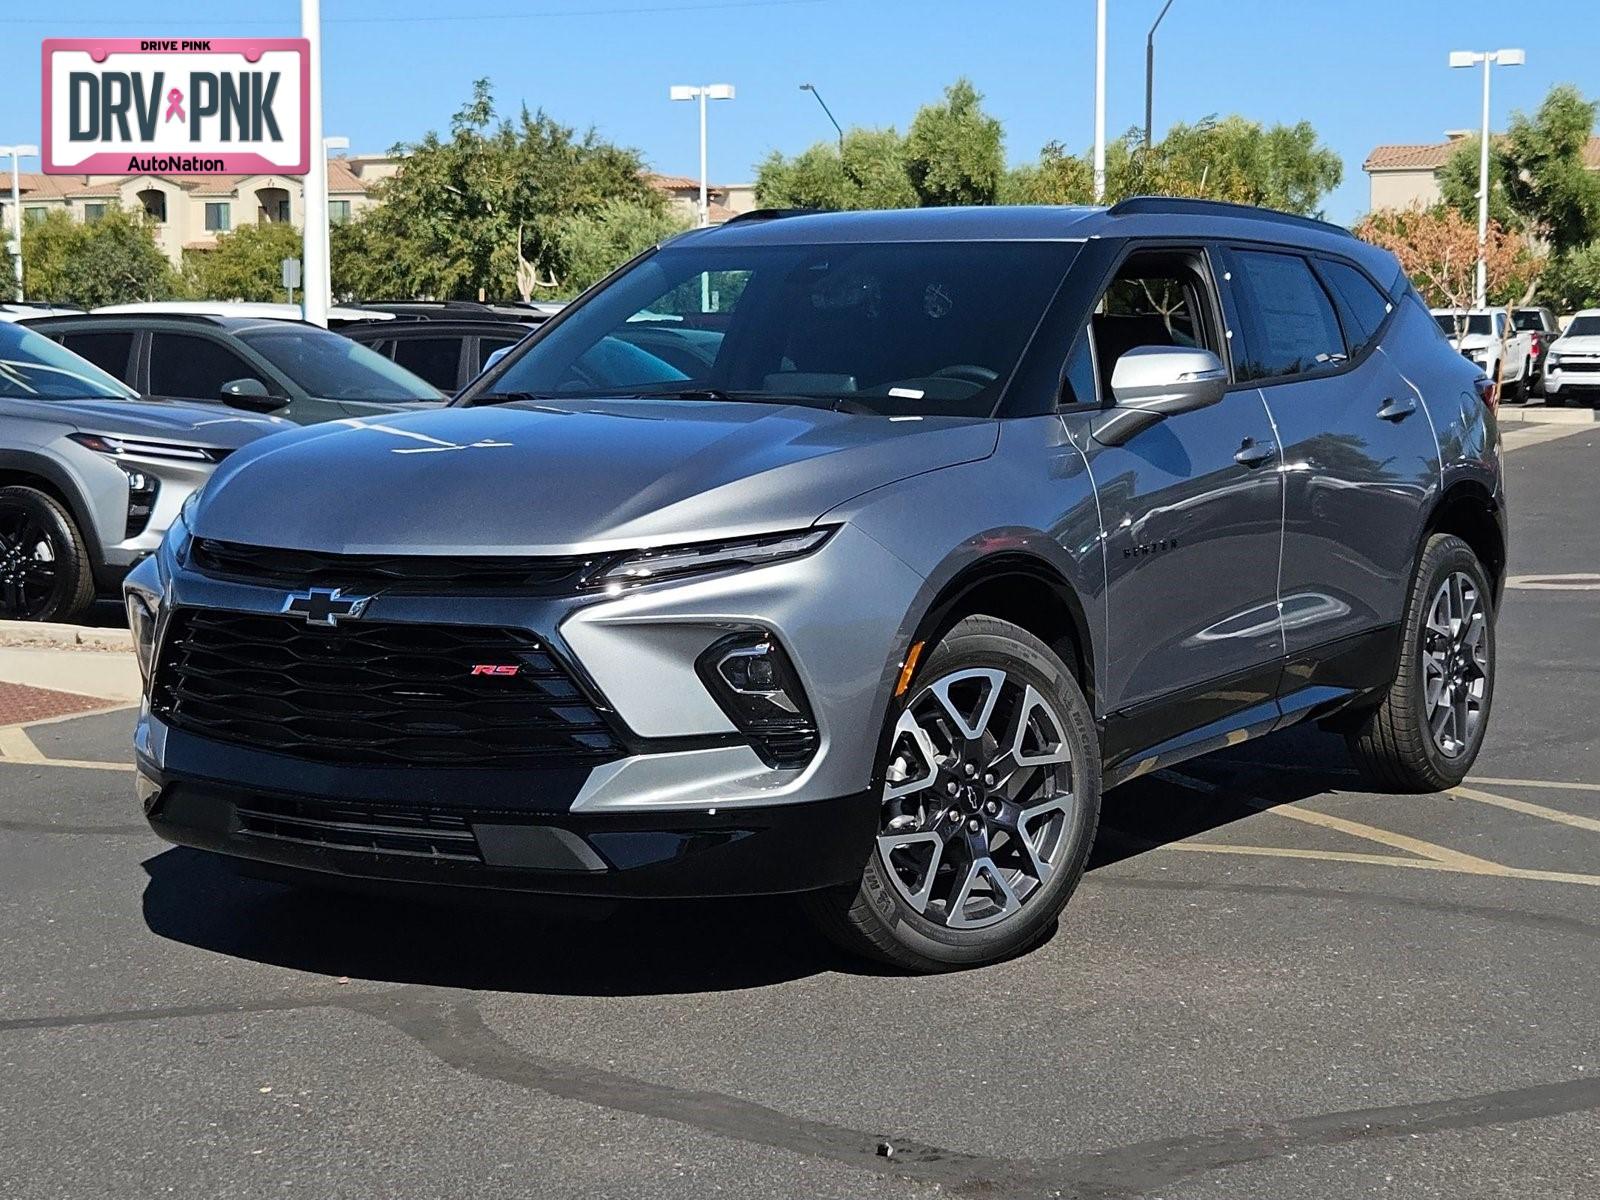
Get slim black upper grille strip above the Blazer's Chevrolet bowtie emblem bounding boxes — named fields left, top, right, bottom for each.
left=190, top=538, right=589, bottom=595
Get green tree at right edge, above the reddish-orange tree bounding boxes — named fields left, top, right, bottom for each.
left=1440, top=83, right=1600, bottom=256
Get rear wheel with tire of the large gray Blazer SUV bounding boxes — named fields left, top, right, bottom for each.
left=1347, top=534, right=1494, bottom=792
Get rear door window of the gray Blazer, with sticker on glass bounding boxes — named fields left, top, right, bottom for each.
left=1232, top=250, right=1346, bottom=381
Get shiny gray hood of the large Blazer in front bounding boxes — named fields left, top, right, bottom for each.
left=194, top=400, right=998, bottom=555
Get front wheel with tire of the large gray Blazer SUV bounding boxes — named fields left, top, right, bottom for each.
left=803, top=616, right=1101, bottom=971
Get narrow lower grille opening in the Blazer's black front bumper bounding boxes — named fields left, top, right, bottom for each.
left=234, top=797, right=483, bottom=862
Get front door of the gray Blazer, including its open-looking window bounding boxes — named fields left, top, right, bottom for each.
left=1069, top=241, right=1283, bottom=758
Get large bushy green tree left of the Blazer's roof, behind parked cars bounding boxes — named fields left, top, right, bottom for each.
left=334, top=80, right=666, bottom=299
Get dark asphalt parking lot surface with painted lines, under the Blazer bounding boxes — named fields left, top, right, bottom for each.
left=0, top=426, right=1600, bottom=1200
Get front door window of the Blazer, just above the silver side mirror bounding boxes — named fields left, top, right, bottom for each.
left=1090, top=251, right=1221, bottom=395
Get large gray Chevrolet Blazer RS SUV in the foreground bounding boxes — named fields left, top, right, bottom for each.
left=126, top=198, right=1506, bottom=970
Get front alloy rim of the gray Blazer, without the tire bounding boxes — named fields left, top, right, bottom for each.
left=878, top=669, right=1083, bottom=930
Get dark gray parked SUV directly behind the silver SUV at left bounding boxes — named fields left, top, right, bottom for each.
left=27, top=314, right=443, bottom=426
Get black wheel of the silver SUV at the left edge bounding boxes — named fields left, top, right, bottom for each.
left=0, top=486, right=94, bottom=621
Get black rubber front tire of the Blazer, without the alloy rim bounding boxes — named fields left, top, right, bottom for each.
left=861, top=618, right=1101, bottom=965
